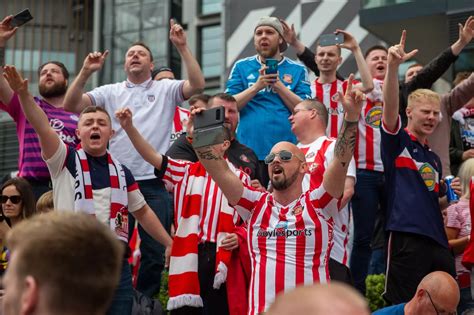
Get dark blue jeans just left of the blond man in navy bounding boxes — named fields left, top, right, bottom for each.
left=350, top=169, right=385, bottom=296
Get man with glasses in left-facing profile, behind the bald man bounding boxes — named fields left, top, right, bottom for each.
left=289, top=100, right=356, bottom=284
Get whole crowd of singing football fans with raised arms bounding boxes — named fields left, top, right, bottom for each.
left=0, top=9, right=474, bottom=315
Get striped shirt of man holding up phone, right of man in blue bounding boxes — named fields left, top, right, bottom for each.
left=311, top=79, right=347, bottom=138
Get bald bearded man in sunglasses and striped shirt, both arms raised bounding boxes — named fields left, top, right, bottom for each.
left=191, top=76, right=362, bottom=314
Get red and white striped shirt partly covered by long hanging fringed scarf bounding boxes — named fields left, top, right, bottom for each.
left=163, top=158, right=250, bottom=243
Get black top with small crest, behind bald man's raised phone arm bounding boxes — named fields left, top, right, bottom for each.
left=166, top=134, right=262, bottom=183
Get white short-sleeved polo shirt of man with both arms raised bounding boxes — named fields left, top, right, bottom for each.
left=87, top=79, right=184, bottom=180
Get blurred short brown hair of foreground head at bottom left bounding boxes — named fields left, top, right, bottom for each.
left=5, top=211, right=125, bottom=315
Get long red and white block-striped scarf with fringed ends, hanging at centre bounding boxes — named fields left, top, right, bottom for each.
left=168, top=162, right=235, bottom=310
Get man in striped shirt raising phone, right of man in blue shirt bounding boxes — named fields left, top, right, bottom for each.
left=311, top=30, right=373, bottom=138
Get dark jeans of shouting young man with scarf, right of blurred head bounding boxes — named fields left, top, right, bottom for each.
left=107, top=259, right=133, bottom=315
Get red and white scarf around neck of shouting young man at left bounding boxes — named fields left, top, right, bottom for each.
left=74, top=144, right=128, bottom=243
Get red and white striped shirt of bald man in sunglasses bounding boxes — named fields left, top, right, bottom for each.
left=235, top=185, right=337, bottom=314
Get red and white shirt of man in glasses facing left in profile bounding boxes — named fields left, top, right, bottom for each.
left=297, top=136, right=356, bottom=266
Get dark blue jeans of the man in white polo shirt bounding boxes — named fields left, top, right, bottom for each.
left=130, top=178, right=172, bottom=298
